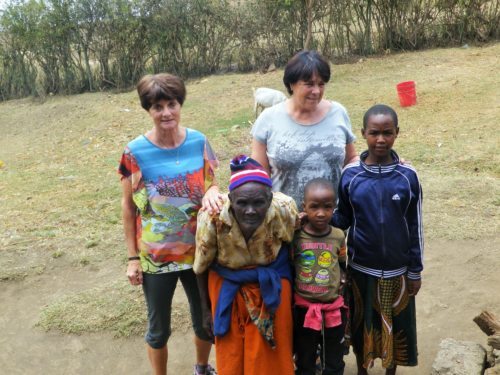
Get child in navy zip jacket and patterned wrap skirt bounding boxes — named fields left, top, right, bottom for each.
left=332, top=104, right=423, bottom=374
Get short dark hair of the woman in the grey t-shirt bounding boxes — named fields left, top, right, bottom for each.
left=283, top=50, right=330, bottom=95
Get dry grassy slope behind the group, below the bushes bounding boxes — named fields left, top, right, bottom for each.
left=0, top=44, right=500, bottom=336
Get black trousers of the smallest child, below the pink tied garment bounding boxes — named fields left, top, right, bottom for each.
left=293, top=306, right=347, bottom=375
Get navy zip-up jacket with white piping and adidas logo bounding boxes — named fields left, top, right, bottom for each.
left=332, top=151, right=424, bottom=279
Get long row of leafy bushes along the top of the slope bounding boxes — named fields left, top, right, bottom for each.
left=0, top=0, right=500, bottom=100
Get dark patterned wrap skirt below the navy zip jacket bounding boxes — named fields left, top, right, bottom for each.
left=349, top=268, right=418, bottom=368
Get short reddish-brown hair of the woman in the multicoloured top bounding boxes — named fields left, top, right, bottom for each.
left=137, top=73, right=186, bottom=111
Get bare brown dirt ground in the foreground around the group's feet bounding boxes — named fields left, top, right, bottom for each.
left=0, top=238, right=500, bottom=375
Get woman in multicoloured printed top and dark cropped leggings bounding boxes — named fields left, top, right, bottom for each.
left=119, top=74, right=221, bottom=374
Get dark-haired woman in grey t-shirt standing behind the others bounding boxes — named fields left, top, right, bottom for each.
left=252, top=51, right=359, bottom=208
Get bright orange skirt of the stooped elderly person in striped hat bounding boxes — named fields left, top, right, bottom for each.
left=208, top=271, right=294, bottom=375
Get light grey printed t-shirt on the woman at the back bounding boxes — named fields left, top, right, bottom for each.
left=252, top=101, right=356, bottom=209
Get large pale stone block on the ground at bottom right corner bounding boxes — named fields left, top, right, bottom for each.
left=431, top=338, right=486, bottom=375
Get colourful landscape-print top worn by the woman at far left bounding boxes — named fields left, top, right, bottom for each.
left=119, top=130, right=217, bottom=273
